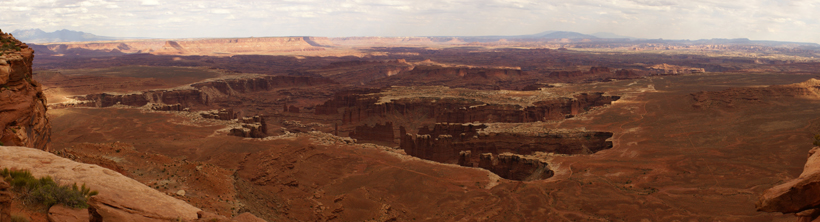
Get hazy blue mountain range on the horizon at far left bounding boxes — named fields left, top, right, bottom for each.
left=11, top=29, right=134, bottom=43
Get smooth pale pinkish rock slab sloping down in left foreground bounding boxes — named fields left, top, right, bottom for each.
left=0, top=146, right=200, bottom=221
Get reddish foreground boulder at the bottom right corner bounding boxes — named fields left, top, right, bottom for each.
left=757, top=147, right=820, bottom=221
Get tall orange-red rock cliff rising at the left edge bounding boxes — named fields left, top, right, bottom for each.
left=0, top=31, right=51, bottom=150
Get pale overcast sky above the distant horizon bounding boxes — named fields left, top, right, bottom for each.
left=0, top=0, right=820, bottom=43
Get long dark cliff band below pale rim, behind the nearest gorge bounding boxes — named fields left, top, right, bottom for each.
left=316, top=92, right=620, bottom=124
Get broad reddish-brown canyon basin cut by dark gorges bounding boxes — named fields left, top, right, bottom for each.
left=24, top=37, right=820, bottom=221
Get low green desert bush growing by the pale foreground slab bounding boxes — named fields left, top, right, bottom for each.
left=0, top=168, right=97, bottom=209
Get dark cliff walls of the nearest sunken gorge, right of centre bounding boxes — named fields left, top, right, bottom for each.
left=400, top=123, right=613, bottom=180
